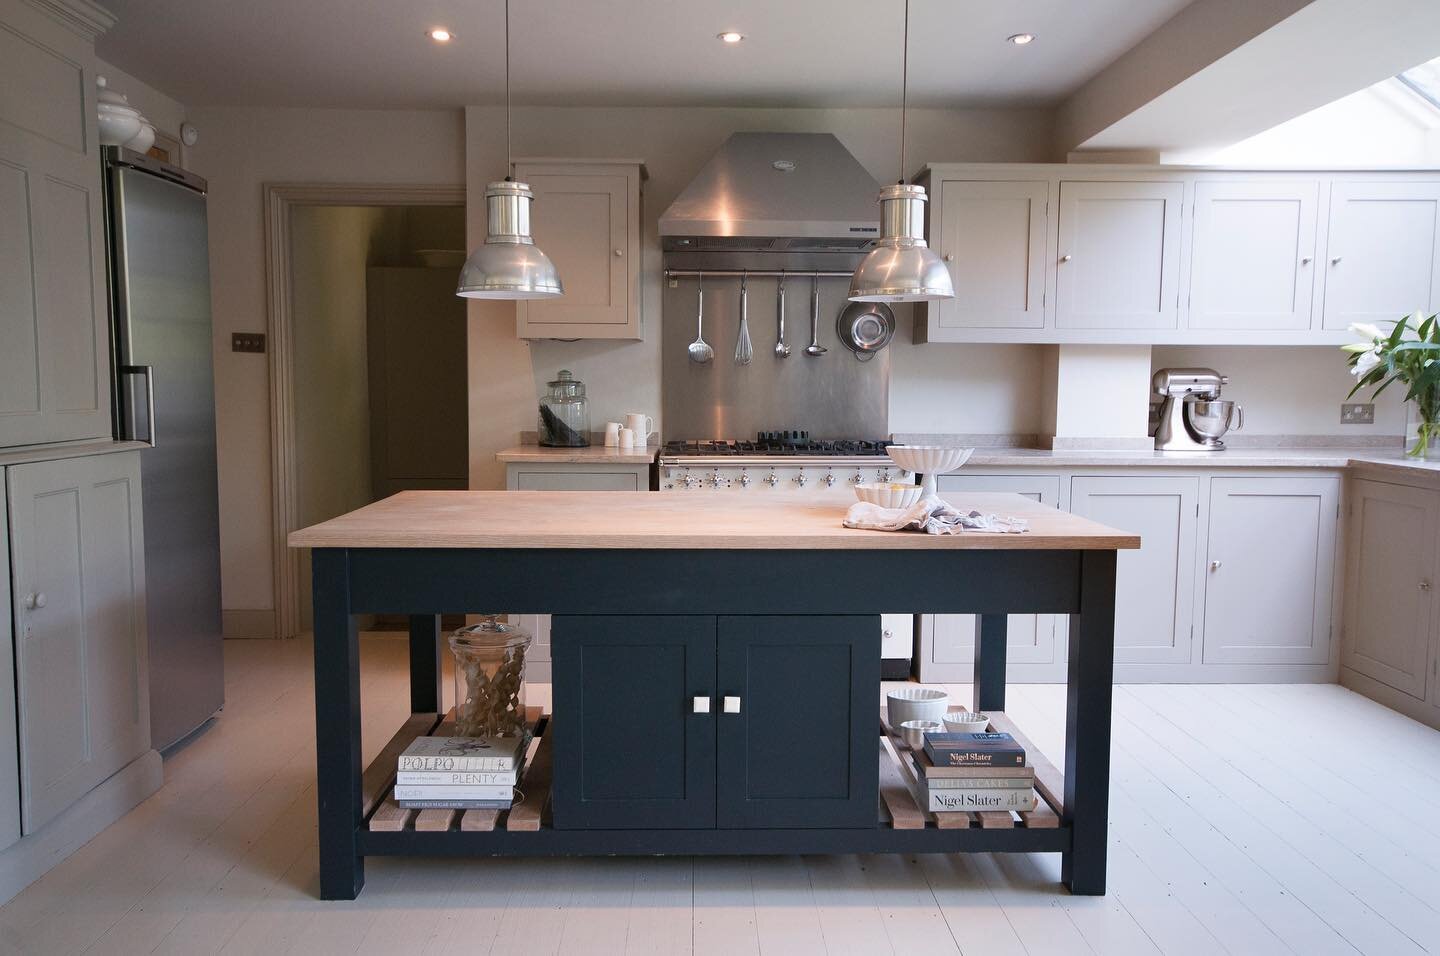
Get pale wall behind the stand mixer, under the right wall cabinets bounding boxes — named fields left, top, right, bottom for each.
left=1151, top=346, right=1405, bottom=438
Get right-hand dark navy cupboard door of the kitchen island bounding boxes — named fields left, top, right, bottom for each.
left=716, top=615, right=880, bottom=828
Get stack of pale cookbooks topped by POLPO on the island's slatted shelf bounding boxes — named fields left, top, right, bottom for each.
left=395, top=737, right=524, bottom=811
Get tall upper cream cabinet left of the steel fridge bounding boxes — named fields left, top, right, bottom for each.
left=0, top=0, right=111, bottom=446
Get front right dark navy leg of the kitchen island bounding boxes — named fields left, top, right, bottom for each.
left=1060, top=551, right=1115, bottom=896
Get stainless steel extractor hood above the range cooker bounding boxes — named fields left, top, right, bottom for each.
left=660, top=132, right=880, bottom=271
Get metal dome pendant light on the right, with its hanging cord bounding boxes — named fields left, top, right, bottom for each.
left=850, top=0, right=955, bottom=302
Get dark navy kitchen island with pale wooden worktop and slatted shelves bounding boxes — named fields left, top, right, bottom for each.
left=289, top=491, right=1139, bottom=900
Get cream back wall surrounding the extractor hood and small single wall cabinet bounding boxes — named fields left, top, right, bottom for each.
left=465, top=107, right=1051, bottom=488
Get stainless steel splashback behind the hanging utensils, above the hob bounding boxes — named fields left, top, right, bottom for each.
left=661, top=276, right=890, bottom=439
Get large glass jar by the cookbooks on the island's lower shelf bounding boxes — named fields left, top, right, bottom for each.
left=449, top=615, right=530, bottom=737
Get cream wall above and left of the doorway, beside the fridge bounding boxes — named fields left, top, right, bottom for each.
left=187, top=107, right=465, bottom=610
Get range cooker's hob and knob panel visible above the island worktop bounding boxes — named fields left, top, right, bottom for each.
left=657, top=430, right=912, bottom=501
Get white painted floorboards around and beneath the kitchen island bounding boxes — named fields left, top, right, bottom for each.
left=0, top=635, right=1440, bottom=956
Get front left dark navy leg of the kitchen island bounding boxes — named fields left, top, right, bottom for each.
left=311, top=549, right=364, bottom=900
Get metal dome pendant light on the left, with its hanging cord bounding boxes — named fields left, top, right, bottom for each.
left=455, top=0, right=564, bottom=299
